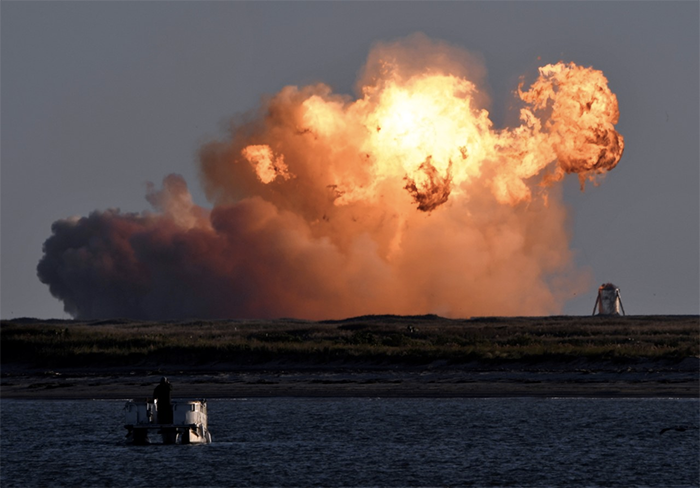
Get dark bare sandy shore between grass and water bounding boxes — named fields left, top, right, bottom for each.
left=0, top=358, right=700, bottom=399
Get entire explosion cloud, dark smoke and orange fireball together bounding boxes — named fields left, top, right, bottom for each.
left=38, top=35, right=624, bottom=319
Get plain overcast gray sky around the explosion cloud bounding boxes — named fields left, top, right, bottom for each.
left=0, top=1, right=700, bottom=318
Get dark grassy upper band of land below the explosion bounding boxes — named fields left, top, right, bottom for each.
left=0, top=315, right=700, bottom=368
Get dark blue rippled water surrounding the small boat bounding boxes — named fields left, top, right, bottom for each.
left=0, top=398, right=700, bottom=487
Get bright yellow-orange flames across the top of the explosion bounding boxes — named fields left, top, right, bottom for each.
left=235, top=62, right=624, bottom=211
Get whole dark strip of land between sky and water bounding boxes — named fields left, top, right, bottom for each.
left=0, top=315, right=700, bottom=398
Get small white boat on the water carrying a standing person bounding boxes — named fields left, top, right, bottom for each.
left=124, top=400, right=211, bottom=445
